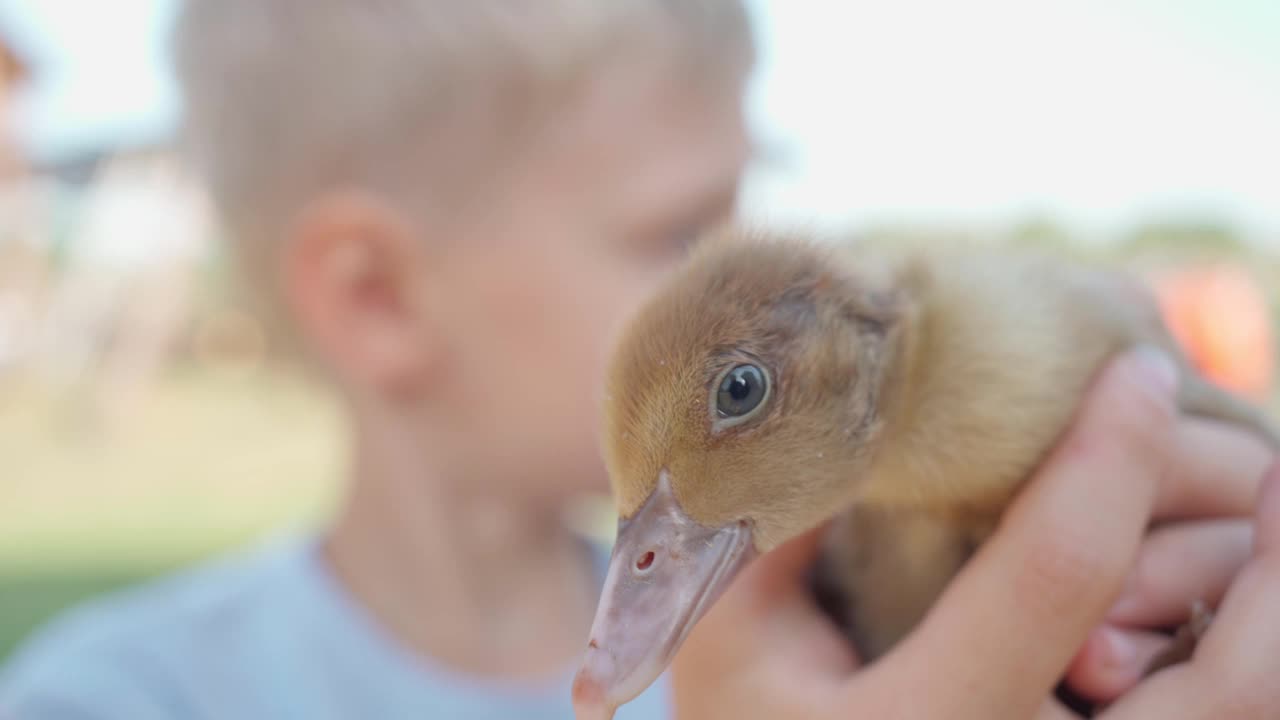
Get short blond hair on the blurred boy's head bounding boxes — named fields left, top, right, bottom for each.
left=174, top=0, right=753, bottom=288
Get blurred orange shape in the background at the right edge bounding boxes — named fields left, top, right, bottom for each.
left=1155, top=265, right=1276, bottom=401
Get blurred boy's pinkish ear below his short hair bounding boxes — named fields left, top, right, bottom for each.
left=280, top=192, right=433, bottom=395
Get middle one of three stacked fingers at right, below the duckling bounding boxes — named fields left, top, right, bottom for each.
left=1107, top=520, right=1253, bottom=628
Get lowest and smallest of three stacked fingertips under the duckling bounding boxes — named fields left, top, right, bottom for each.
left=1066, top=625, right=1174, bottom=702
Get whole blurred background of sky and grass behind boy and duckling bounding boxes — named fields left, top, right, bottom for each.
left=0, top=0, right=1280, bottom=659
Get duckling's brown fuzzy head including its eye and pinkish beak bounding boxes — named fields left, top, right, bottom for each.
left=575, top=232, right=901, bottom=707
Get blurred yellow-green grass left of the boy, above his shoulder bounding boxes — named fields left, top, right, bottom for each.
left=0, top=370, right=346, bottom=660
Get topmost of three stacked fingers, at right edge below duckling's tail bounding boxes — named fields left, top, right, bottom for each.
left=1156, top=418, right=1275, bottom=520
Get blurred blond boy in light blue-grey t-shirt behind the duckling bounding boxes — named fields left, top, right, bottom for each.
left=0, top=0, right=753, bottom=720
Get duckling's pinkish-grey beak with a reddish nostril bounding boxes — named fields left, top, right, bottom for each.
left=573, top=470, right=755, bottom=720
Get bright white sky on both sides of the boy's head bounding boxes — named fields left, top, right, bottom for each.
left=0, top=0, right=1280, bottom=237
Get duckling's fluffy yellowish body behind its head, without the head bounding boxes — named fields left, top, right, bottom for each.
left=798, top=247, right=1276, bottom=660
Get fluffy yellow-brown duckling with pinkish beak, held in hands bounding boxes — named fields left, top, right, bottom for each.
left=573, top=229, right=1280, bottom=717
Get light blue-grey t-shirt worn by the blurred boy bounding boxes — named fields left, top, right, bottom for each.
left=0, top=538, right=671, bottom=720
